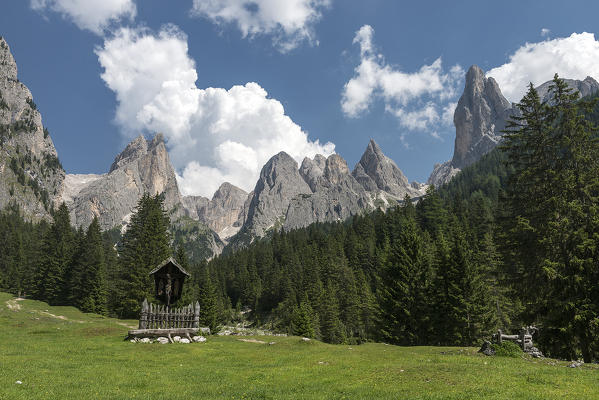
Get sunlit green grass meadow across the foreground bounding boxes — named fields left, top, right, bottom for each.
left=0, top=293, right=599, bottom=400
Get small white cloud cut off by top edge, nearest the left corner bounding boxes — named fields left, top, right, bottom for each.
left=30, top=0, right=136, bottom=35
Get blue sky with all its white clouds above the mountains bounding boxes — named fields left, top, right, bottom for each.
left=0, top=0, right=599, bottom=197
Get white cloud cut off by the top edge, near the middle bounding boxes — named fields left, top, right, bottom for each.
left=191, top=0, right=331, bottom=52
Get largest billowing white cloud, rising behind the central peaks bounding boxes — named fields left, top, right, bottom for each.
left=96, top=26, right=335, bottom=197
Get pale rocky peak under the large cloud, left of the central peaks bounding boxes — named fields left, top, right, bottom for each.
left=63, top=134, right=181, bottom=229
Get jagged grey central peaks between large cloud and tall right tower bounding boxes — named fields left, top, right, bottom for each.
left=232, top=140, right=426, bottom=247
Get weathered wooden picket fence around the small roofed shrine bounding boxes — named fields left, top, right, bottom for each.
left=139, top=299, right=200, bottom=329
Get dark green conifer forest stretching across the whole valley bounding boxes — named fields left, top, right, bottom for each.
left=0, top=75, right=599, bottom=362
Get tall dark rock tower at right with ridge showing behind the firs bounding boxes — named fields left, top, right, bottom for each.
left=427, top=65, right=599, bottom=186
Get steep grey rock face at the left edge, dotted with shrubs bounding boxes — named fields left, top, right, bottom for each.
left=0, top=37, right=65, bottom=221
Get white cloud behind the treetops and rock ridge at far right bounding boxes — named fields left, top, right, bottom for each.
left=487, top=32, right=599, bottom=102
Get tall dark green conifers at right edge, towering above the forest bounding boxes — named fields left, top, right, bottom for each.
left=504, top=75, right=599, bottom=362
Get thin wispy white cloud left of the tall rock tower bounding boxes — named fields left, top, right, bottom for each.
left=341, top=25, right=464, bottom=136
